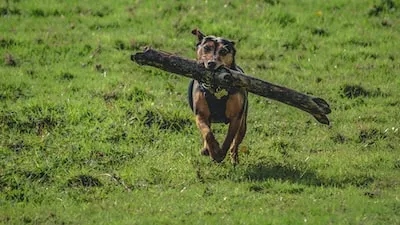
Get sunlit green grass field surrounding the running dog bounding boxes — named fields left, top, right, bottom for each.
left=0, top=0, right=400, bottom=224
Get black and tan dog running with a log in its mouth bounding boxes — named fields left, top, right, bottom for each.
left=188, top=29, right=248, bottom=165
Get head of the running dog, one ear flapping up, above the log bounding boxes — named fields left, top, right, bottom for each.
left=192, top=29, right=236, bottom=70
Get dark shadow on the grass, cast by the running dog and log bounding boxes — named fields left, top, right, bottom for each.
left=245, top=164, right=374, bottom=188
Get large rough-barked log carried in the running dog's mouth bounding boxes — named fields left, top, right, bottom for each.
left=131, top=48, right=331, bottom=125
